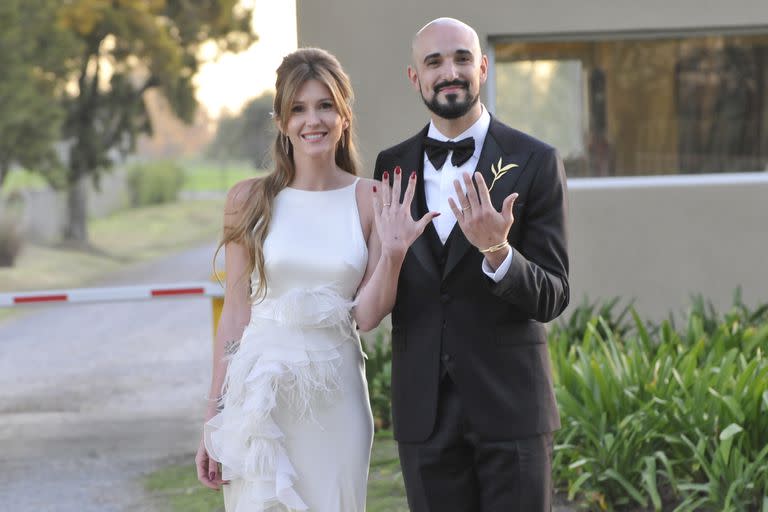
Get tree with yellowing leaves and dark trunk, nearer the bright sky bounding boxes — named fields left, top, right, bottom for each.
left=58, top=0, right=256, bottom=244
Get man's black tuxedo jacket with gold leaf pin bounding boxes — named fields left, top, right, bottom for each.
left=374, top=118, right=569, bottom=442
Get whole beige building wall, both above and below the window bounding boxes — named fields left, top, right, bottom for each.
left=297, top=0, right=768, bottom=318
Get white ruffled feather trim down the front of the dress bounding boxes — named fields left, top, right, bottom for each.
left=204, top=286, right=354, bottom=512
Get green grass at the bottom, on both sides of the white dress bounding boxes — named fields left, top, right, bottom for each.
left=144, top=432, right=408, bottom=512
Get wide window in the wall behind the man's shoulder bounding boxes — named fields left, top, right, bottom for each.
left=494, top=35, right=768, bottom=177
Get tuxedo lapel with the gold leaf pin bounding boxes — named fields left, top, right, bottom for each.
left=443, top=117, right=530, bottom=279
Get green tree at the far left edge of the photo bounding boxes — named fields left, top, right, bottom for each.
left=0, top=0, right=76, bottom=187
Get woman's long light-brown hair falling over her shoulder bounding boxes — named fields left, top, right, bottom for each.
left=214, top=48, right=359, bottom=301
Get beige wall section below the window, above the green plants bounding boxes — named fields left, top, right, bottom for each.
left=569, top=177, right=768, bottom=319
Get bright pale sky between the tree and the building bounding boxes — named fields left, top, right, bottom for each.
left=196, top=0, right=297, bottom=118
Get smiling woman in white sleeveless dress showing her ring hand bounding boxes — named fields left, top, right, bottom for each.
left=196, top=48, right=437, bottom=512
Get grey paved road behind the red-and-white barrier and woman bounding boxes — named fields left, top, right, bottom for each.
left=0, top=244, right=219, bottom=512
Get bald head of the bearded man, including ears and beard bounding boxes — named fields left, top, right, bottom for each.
left=408, top=24, right=488, bottom=119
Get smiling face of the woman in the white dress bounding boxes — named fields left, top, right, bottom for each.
left=285, top=80, right=346, bottom=157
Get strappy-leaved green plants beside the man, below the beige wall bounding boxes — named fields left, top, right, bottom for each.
left=550, top=295, right=768, bottom=512
